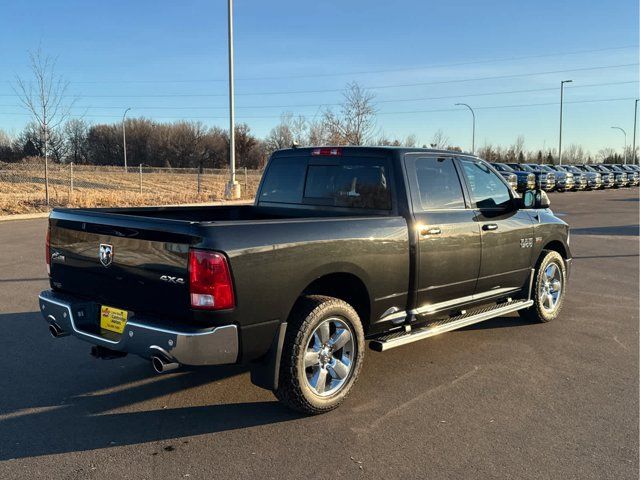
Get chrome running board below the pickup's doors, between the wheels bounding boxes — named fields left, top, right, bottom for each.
left=369, top=300, right=533, bottom=352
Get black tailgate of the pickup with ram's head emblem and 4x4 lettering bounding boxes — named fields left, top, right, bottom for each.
left=49, top=210, right=201, bottom=318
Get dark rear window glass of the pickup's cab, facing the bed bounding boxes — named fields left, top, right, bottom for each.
left=260, top=158, right=391, bottom=210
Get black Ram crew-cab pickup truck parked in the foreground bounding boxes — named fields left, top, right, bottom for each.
left=39, top=147, right=571, bottom=414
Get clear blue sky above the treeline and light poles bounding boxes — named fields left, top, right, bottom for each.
left=0, top=0, right=640, bottom=152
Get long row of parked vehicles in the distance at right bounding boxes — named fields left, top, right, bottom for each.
left=492, top=163, right=640, bottom=192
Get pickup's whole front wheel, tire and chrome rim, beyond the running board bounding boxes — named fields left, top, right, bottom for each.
left=519, top=250, right=567, bottom=322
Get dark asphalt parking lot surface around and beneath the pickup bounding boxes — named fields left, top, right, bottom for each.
left=0, top=188, right=639, bottom=480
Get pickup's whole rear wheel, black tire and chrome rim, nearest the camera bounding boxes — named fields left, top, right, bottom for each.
left=275, top=295, right=364, bottom=415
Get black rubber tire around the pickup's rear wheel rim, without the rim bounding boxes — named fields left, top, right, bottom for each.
left=274, top=295, right=365, bottom=415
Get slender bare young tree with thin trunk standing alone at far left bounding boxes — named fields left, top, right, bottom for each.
left=14, top=48, right=74, bottom=205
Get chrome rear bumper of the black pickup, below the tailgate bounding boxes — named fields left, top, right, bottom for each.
left=39, top=290, right=239, bottom=365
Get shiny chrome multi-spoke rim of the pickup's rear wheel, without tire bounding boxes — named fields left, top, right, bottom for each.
left=303, top=317, right=356, bottom=397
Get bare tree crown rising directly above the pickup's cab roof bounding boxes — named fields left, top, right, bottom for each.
left=323, top=82, right=376, bottom=145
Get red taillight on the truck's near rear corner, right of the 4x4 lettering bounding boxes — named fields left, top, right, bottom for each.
left=189, top=250, right=236, bottom=310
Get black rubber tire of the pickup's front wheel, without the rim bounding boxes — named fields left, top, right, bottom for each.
left=518, top=250, right=567, bottom=322
